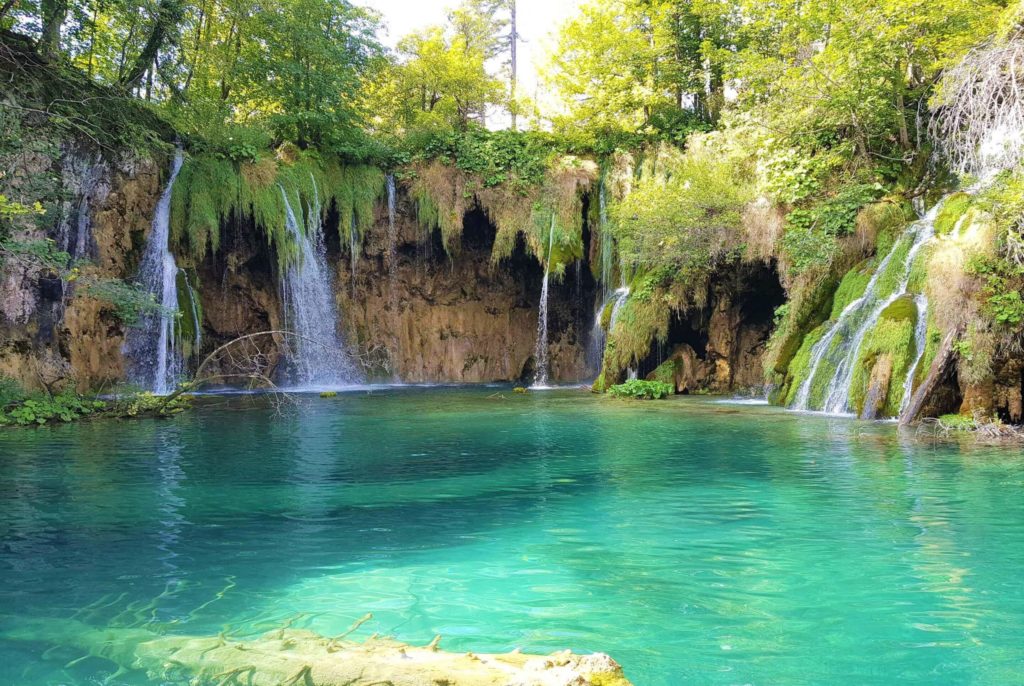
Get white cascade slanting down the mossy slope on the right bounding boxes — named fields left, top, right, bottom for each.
left=793, top=202, right=943, bottom=414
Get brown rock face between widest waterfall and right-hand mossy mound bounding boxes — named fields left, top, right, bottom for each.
left=336, top=201, right=594, bottom=383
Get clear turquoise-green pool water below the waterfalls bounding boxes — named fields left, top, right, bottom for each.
left=0, top=389, right=1024, bottom=686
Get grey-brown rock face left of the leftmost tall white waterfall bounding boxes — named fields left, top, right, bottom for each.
left=0, top=141, right=160, bottom=390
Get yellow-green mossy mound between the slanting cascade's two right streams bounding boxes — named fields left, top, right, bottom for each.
left=850, top=296, right=918, bottom=417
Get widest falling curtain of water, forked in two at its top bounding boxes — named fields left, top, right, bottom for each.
left=279, top=180, right=357, bottom=388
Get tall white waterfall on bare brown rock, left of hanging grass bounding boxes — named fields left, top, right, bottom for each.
left=123, top=149, right=184, bottom=395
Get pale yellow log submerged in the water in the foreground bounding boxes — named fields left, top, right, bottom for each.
left=5, top=619, right=631, bottom=686
